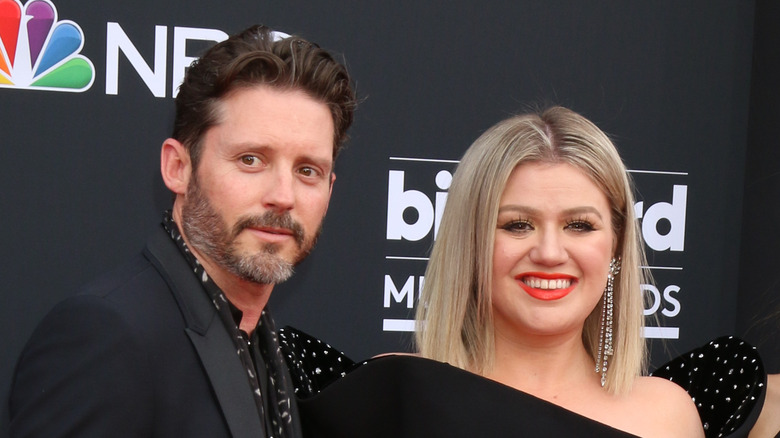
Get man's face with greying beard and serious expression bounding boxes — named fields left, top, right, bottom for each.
left=181, top=85, right=335, bottom=284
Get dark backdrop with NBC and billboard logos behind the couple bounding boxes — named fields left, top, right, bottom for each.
left=0, top=0, right=780, bottom=432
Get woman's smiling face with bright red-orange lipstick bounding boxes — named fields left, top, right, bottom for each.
left=492, top=163, right=615, bottom=340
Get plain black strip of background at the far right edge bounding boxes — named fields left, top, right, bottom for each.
left=728, top=1, right=780, bottom=373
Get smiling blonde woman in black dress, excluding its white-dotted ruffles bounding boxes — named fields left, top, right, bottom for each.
left=284, top=107, right=703, bottom=437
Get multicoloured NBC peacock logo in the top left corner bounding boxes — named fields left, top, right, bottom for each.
left=0, top=0, right=95, bottom=92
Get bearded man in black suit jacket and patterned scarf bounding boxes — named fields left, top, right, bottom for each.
left=10, top=26, right=355, bottom=437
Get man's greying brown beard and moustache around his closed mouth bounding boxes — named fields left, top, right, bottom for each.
left=181, top=179, right=320, bottom=284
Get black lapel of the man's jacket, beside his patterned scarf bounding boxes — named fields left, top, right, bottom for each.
left=145, top=230, right=264, bottom=438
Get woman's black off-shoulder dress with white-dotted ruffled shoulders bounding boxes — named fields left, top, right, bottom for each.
left=279, top=327, right=766, bottom=438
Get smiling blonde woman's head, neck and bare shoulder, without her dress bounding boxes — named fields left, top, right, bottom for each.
left=417, top=107, right=702, bottom=437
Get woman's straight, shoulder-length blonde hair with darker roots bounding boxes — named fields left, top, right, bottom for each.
left=416, top=107, right=646, bottom=393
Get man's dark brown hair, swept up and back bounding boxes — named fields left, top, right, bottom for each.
left=173, top=25, right=357, bottom=170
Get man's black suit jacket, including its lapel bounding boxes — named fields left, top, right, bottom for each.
left=9, top=227, right=274, bottom=438
